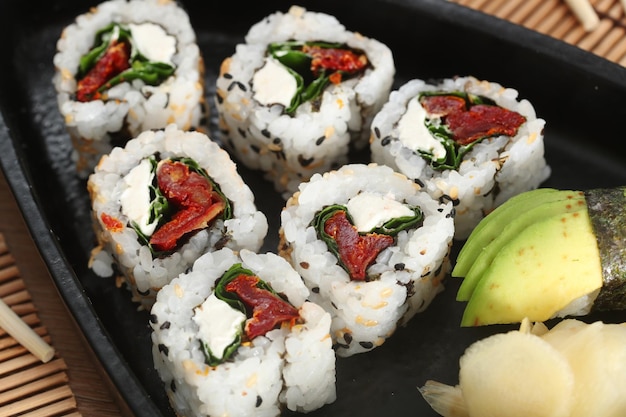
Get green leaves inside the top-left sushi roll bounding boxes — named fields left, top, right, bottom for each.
left=77, top=23, right=175, bottom=92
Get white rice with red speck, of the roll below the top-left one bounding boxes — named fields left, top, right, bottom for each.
left=87, top=124, right=268, bottom=307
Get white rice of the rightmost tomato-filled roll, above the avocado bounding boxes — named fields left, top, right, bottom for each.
left=370, top=77, right=550, bottom=239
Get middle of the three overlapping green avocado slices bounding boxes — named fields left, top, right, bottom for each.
left=456, top=191, right=585, bottom=301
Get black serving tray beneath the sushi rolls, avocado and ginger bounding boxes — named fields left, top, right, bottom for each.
left=0, top=0, right=626, bottom=417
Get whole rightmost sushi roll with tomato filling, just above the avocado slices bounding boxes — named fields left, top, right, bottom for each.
left=370, top=77, right=550, bottom=240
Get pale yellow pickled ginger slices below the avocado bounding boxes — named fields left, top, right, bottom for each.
left=420, top=319, right=626, bottom=417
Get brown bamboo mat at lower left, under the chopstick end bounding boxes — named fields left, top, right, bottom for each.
left=0, top=233, right=81, bottom=417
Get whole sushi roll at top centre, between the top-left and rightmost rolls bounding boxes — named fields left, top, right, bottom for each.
left=216, top=6, right=395, bottom=198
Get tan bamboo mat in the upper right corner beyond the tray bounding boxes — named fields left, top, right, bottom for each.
left=450, top=0, right=626, bottom=66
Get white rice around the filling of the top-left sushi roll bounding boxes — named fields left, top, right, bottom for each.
left=53, top=0, right=207, bottom=177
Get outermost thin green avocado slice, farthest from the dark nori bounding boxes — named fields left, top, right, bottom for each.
left=452, top=188, right=565, bottom=277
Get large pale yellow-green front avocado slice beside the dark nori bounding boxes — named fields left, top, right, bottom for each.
left=461, top=207, right=602, bottom=326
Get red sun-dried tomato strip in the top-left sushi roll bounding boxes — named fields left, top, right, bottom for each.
left=76, top=42, right=131, bottom=102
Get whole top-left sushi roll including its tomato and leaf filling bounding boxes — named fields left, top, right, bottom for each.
left=53, top=0, right=207, bottom=177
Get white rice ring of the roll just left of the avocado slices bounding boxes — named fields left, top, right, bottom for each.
left=279, top=164, right=454, bottom=356
